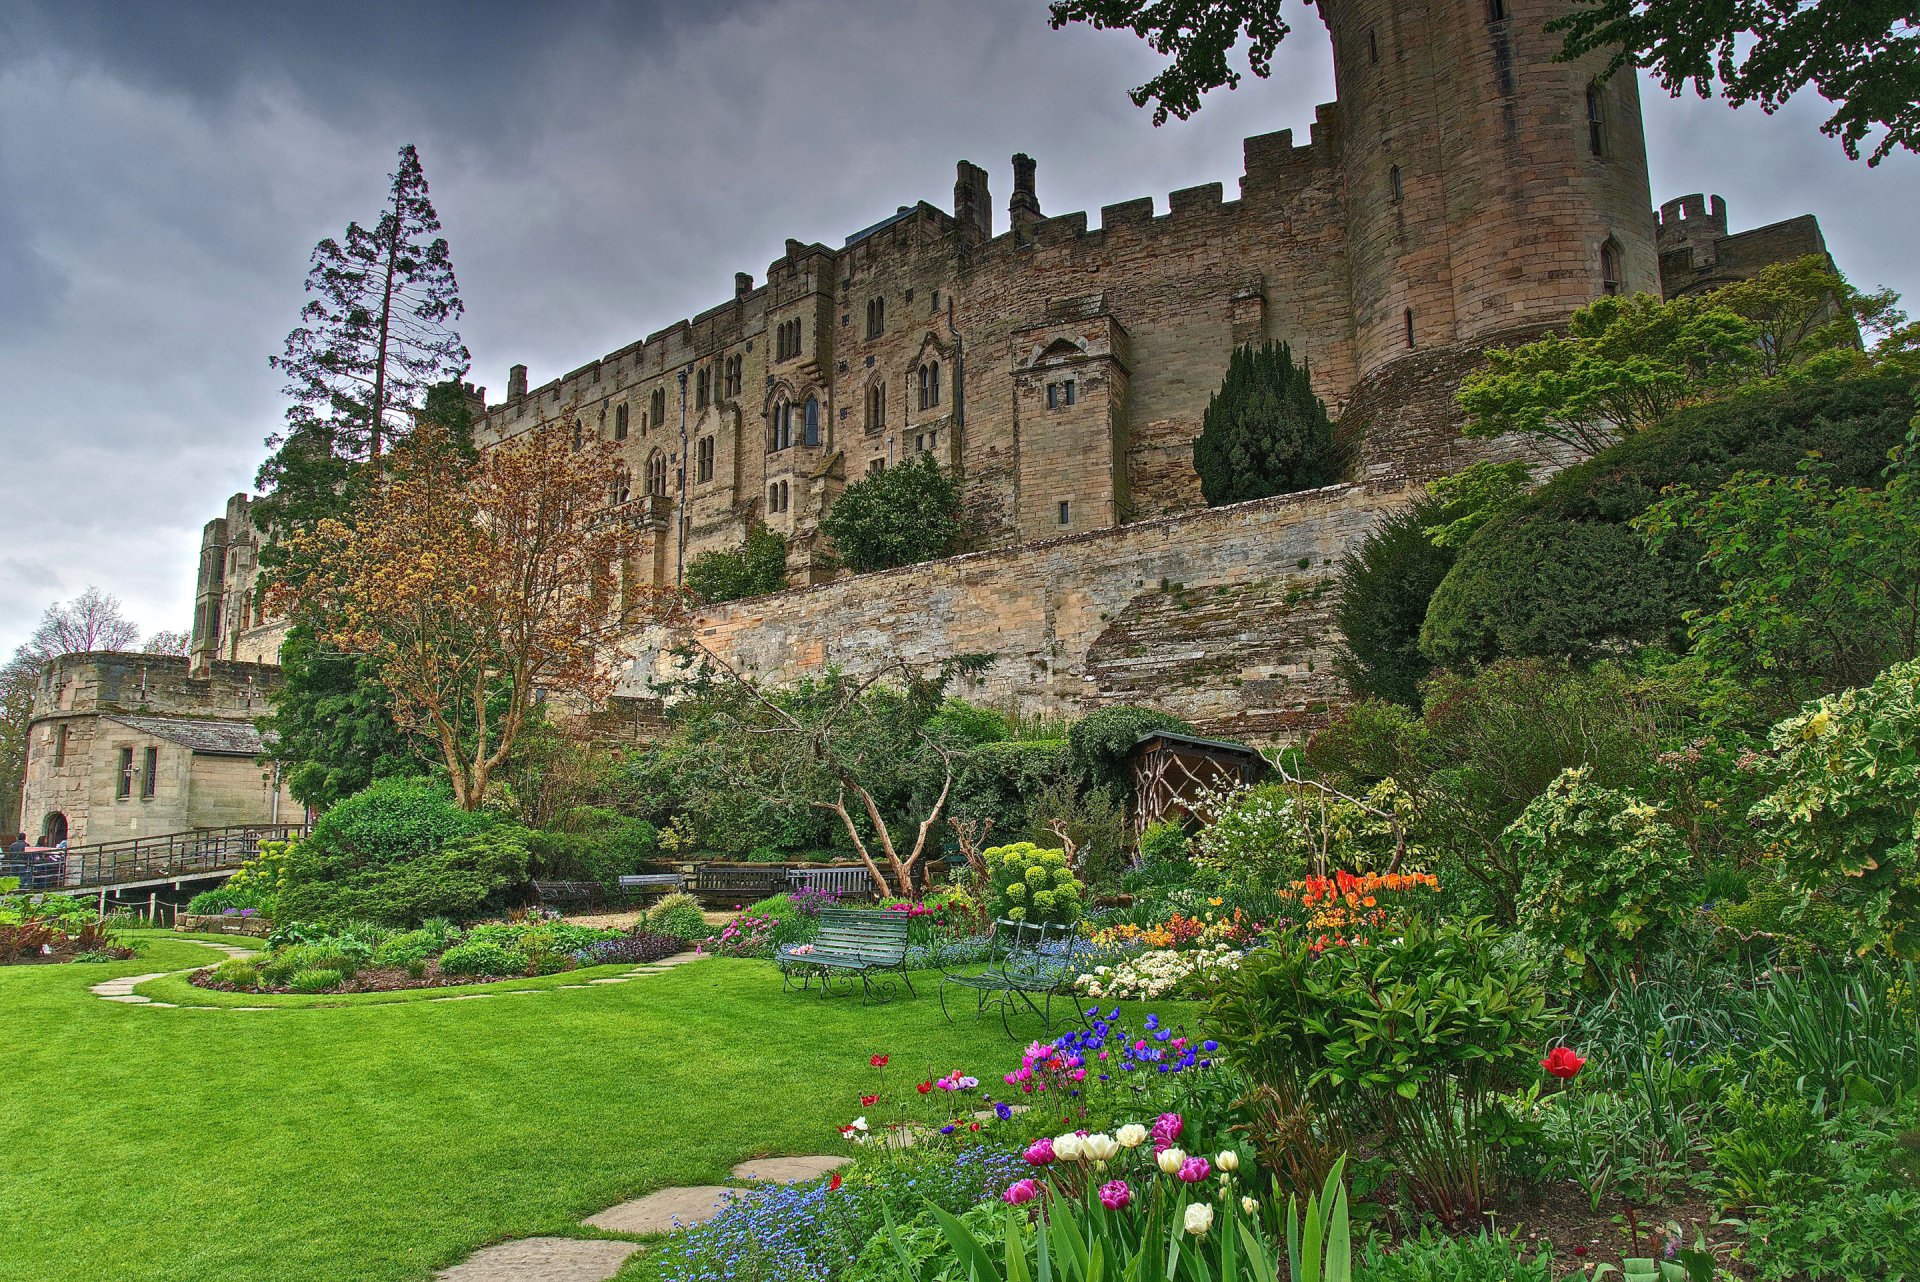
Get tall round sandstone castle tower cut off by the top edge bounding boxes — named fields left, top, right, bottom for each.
left=1319, top=0, right=1661, bottom=472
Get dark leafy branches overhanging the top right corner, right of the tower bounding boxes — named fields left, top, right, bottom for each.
left=1548, top=0, right=1920, bottom=165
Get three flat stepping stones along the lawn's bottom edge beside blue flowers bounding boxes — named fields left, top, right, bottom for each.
left=436, top=1153, right=852, bottom=1282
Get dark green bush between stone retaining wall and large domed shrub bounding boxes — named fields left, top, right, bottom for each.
left=1332, top=499, right=1453, bottom=708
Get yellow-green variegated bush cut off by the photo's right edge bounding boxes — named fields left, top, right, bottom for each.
left=1753, top=662, right=1920, bottom=956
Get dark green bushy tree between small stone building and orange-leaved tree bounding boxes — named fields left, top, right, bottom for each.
left=259, top=624, right=428, bottom=810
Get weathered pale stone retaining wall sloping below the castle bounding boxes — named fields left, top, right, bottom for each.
left=622, top=484, right=1407, bottom=741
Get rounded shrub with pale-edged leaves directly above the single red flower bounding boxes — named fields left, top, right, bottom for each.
left=1503, top=766, right=1699, bottom=977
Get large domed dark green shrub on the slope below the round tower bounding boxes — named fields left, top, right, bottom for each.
left=1421, top=374, right=1914, bottom=664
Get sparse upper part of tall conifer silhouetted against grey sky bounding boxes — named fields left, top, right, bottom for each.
left=257, top=144, right=468, bottom=552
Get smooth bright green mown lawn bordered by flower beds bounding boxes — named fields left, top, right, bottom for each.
left=0, top=935, right=1039, bottom=1282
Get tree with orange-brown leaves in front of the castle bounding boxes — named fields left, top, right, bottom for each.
left=269, top=411, right=674, bottom=810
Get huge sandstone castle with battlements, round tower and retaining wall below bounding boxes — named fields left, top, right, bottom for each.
left=22, top=0, right=1824, bottom=852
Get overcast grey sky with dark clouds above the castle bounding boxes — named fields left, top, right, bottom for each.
left=0, top=0, right=1920, bottom=654
